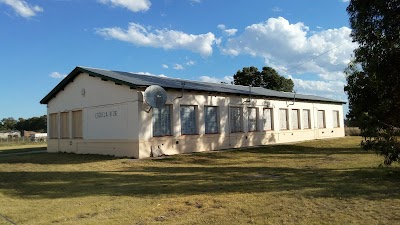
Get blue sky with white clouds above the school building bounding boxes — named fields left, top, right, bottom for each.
left=0, top=0, right=356, bottom=119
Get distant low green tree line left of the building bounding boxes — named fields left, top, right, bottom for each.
left=0, top=115, right=47, bottom=132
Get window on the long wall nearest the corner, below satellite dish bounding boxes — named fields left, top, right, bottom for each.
left=153, top=105, right=171, bottom=137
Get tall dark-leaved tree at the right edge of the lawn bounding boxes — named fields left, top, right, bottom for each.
left=344, top=0, right=400, bottom=165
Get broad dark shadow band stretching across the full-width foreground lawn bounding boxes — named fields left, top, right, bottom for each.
left=0, top=166, right=400, bottom=199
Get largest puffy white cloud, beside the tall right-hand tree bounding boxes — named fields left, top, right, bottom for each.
left=221, top=17, right=356, bottom=79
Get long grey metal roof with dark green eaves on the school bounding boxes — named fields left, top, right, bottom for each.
left=40, top=66, right=345, bottom=104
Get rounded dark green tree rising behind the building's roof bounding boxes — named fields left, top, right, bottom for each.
left=233, top=66, right=294, bottom=92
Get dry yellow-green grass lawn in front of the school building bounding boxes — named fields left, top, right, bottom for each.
left=0, top=137, right=400, bottom=225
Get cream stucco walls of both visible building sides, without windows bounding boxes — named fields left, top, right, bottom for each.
left=48, top=74, right=344, bottom=158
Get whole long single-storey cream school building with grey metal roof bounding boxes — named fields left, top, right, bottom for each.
left=40, top=67, right=344, bottom=158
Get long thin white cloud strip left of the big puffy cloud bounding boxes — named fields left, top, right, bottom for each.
left=96, top=23, right=217, bottom=56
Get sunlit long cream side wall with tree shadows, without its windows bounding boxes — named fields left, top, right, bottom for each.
left=139, top=91, right=344, bottom=158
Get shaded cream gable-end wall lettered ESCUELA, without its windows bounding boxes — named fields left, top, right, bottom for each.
left=48, top=74, right=139, bottom=157
